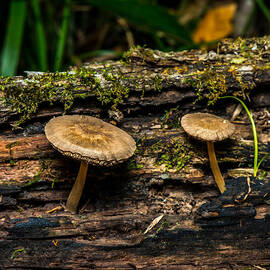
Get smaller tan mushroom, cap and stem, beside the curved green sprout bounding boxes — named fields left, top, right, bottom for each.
left=181, top=113, right=235, bottom=193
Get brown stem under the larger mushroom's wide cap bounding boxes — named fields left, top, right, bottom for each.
left=66, top=161, right=88, bottom=214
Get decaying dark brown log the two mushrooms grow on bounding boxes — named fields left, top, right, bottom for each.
left=0, top=37, right=270, bottom=269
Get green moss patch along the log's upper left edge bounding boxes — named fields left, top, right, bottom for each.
left=0, top=66, right=129, bottom=127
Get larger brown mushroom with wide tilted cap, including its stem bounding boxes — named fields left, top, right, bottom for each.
left=45, top=115, right=136, bottom=213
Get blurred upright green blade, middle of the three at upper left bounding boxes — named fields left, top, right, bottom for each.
left=31, top=0, right=48, bottom=71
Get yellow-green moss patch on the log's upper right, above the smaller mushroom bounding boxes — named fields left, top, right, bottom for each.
left=185, top=37, right=269, bottom=104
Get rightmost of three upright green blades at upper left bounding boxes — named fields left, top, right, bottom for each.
left=54, top=0, right=71, bottom=71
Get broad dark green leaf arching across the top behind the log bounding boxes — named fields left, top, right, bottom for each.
left=83, top=0, right=191, bottom=44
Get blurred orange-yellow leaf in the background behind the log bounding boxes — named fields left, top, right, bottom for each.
left=193, top=3, right=237, bottom=43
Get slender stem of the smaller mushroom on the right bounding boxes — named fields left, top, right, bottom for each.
left=207, top=142, right=226, bottom=193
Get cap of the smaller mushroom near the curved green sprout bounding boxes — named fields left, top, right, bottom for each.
left=181, top=113, right=235, bottom=142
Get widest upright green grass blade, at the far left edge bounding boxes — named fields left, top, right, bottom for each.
left=0, top=0, right=27, bottom=76
